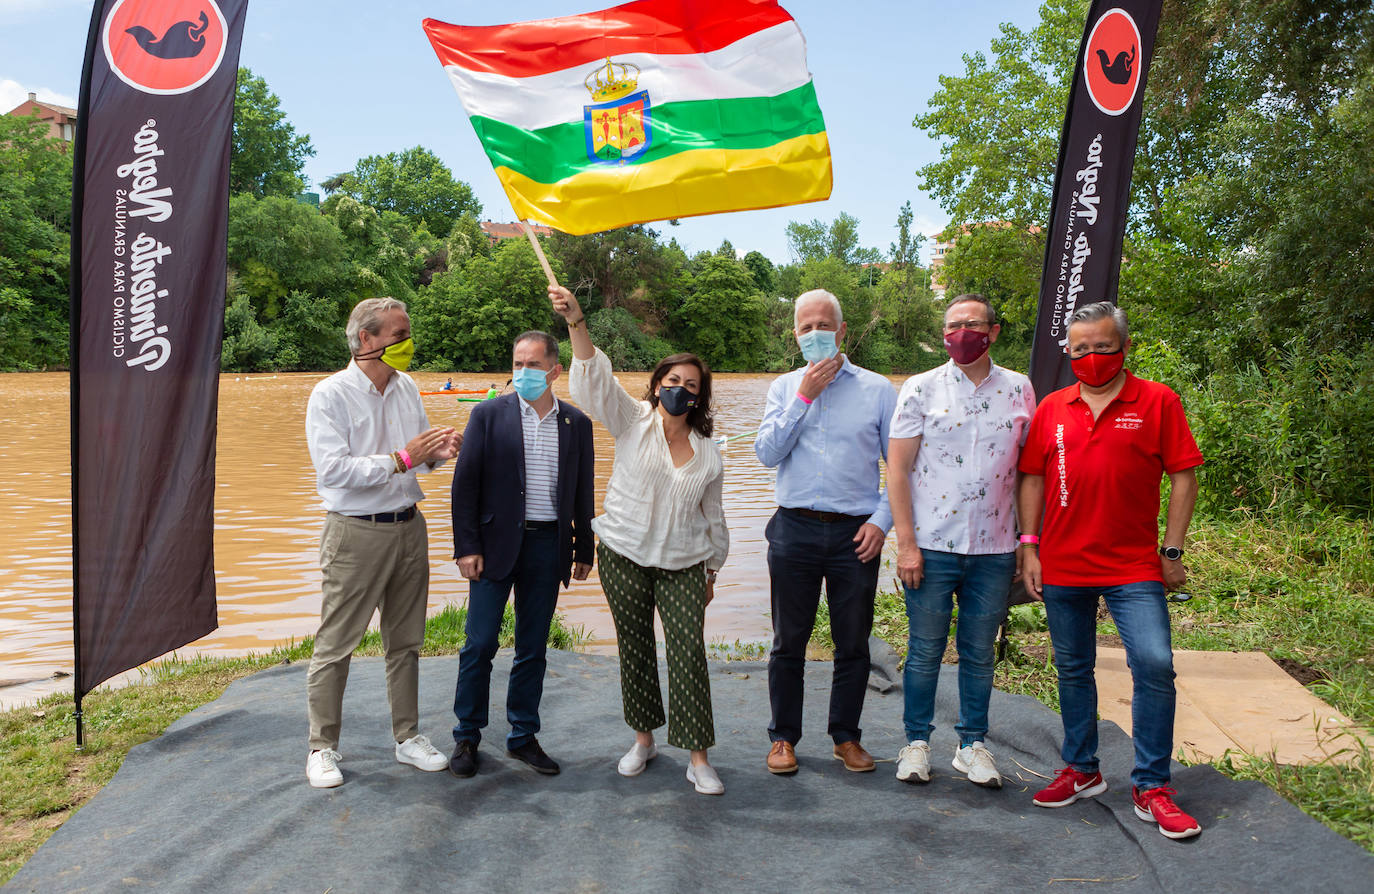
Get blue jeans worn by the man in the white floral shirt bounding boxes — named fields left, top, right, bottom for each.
left=901, top=549, right=1017, bottom=746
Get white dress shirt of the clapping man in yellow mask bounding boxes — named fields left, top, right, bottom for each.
left=305, top=360, right=438, bottom=515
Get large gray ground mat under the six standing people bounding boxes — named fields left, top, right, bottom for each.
left=8, top=651, right=1374, bottom=894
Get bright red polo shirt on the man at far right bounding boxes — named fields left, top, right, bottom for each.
left=1018, top=372, right=1202, bottom=586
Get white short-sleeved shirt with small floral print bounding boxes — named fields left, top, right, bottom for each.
left=889, top=360, right=1035, bottom=556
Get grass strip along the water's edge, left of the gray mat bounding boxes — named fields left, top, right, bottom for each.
left=0, top=604, right=587, bottom=884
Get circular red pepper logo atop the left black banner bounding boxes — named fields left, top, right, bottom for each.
left=102, top=0, right=228, bottom=93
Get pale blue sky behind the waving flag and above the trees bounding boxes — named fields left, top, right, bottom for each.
left=0, top=0, right=1039, bottom=262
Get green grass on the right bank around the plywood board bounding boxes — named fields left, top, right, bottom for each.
left=812, top=511, right=1374, bottom=853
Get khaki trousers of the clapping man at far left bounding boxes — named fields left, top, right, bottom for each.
left=305, top=511, right=429, bottom=751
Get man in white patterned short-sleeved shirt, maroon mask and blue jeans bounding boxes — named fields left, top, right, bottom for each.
left=888, top=295, right=1035, bottom=788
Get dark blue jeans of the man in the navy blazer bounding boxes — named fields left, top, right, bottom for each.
left=453, top=527, right=562, bottom=748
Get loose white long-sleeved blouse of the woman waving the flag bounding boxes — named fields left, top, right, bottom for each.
left=567, top=347, right=730, bottom=570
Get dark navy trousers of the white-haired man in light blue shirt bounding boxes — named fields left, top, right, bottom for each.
left=764, top=509, right=879, bottom=744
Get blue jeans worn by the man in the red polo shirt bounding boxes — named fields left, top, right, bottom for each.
left=1044, top=581, right=1175, bottom=791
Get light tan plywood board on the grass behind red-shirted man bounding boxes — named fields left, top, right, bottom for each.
left=1098, top=647, right=1369, bottom=764
